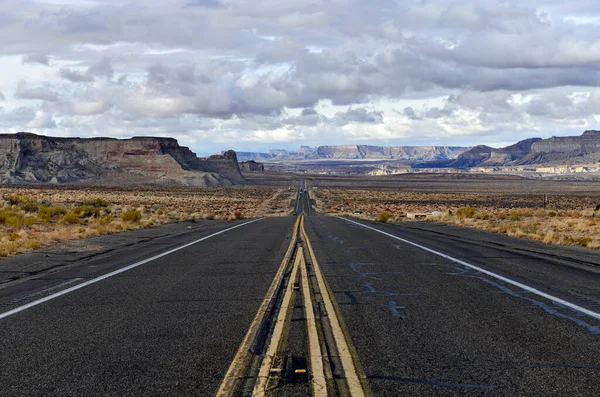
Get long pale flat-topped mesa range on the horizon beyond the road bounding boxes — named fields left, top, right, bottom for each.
left=237, top=145, right=469, bottom=162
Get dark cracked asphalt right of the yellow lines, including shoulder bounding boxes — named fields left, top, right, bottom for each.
left=307, top=217, right=600, bottom=396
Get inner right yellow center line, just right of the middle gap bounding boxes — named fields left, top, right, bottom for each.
left=296, top=248, right=327, bottom=397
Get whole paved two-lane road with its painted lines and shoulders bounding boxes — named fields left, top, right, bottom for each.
left=0, top=186, right=600, bottom=396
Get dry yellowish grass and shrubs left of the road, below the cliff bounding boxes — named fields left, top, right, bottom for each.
left=0, top=187, right=292, bottom=256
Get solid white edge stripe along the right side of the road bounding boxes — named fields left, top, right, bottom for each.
left=336, top=216, right=600, bottom=320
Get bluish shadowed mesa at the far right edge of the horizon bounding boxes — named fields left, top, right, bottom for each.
left=413, top=130, right=600, bottom=168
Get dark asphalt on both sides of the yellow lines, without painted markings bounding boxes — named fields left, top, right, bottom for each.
left=0, top=215, right=600, bottom=396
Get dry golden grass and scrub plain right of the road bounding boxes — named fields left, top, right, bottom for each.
left=311, top=189, right=600, bottom=249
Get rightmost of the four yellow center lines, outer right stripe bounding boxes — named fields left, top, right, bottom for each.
left=300, top=217, right=367, bottom=397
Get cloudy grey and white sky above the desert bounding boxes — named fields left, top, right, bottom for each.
left=0, top=0, right=600, bottom=154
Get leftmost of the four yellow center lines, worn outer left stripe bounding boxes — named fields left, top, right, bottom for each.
left=215, top=218, right=300, bottom=397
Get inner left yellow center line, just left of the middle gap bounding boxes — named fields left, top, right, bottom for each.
left=252, top=248, right=302, bottom=397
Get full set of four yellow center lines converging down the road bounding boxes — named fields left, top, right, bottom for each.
left=216, top=216, right=370, bottom=397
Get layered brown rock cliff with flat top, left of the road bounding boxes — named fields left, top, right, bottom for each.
left=0, top=133, right=244, bottom=186
